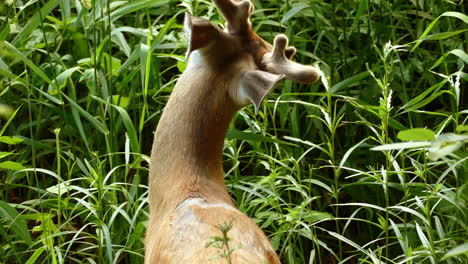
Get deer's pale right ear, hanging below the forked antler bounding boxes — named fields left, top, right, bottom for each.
left=237, top=70, right=284, bottom=114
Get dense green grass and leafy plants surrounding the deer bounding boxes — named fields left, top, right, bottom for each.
left=0, top=0, right=468, bottom=264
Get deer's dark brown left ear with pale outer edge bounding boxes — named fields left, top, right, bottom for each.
left=184, top=13, right=220, bottom=57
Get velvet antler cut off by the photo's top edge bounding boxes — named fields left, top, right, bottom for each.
left=213, top=0, right=254, bottom=34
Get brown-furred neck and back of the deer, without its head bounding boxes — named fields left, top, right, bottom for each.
left=145, top=46, right=280, bottom=264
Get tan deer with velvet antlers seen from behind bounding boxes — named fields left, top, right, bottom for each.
left=145, top=0, right=319, bottom=264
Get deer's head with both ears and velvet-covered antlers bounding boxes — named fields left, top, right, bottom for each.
left=185, top=0, right=319, bottom=113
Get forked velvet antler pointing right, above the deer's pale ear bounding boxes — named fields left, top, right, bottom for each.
left=263, top=34, right=319, bottom=84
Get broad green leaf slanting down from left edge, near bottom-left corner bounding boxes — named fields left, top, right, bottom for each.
left=0, top=200, right=32, bottom=245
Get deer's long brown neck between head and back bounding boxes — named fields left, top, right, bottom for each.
left=149, top=52, right=236, bottom=211
